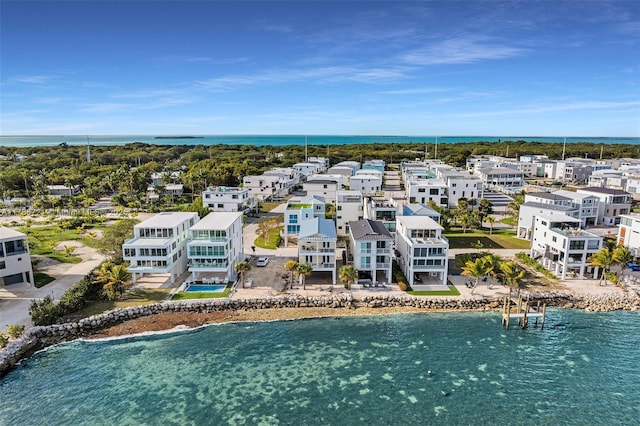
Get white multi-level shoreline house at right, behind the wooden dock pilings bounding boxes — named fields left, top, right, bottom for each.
left=529, top=215, right=603, bottom=280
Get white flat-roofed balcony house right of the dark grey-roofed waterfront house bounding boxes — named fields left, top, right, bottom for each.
left=395, top=216, right=449, bottom=289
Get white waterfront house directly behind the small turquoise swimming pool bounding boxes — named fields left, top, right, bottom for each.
left=187, top=212, right=244, bottom=283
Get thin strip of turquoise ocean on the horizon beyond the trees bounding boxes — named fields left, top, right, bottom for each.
left=0, top=135, right=640, bottom=146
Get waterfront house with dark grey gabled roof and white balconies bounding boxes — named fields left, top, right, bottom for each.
left=349, top=219, right=393, bottom=283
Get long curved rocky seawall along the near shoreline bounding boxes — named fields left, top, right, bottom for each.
left=0, top=292, right=640, bottom=377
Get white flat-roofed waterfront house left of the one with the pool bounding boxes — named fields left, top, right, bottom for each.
left=122, top=212, right=200, bottom=283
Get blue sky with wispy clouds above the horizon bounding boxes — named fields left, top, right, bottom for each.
left=0, top=0, right=640, bottom=136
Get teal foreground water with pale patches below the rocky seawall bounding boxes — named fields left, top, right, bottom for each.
left=0, top=310, right=640, bottom=425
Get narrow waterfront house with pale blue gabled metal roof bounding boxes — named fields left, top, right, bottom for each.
left=298, top=217, right=338, bottom=284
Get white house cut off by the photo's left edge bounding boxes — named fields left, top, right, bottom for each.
left=0, top=226, right=34, bottom=287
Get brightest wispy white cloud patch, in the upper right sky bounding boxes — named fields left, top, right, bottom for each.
left=399, top=36, right=526, bottom=66
